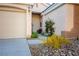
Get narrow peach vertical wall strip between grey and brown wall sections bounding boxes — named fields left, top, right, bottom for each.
left=65, top=4, right=74, bottom=31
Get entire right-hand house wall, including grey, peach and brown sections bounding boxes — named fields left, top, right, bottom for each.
left=42, top=4, right=79, bottom=38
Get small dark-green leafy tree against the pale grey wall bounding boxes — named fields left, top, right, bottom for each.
left=45, top=19, right=55, bottom=36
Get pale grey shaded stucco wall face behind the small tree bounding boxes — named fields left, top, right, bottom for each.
left=42, top=5, right=67, bottom=35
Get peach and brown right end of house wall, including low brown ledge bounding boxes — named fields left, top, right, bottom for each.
left=64, top=4, right=79, bottom=38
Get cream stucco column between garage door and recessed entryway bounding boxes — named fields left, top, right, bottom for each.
left=26, top=6, right=32, bottom=38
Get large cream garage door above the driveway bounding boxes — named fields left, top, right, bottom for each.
left=0, top=11, right=25, bottom=38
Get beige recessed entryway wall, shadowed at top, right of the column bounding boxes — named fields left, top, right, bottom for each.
left=32, top=14, right=41, bottom=32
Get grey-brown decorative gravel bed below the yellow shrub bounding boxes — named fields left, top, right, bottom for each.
left=30, top=39, right=79, bottom=56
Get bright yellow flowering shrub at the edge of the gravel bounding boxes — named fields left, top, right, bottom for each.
left=43, top=34, right=70, bottom=49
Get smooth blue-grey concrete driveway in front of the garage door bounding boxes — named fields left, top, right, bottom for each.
left=0, top=39, right=31, bottom=56
